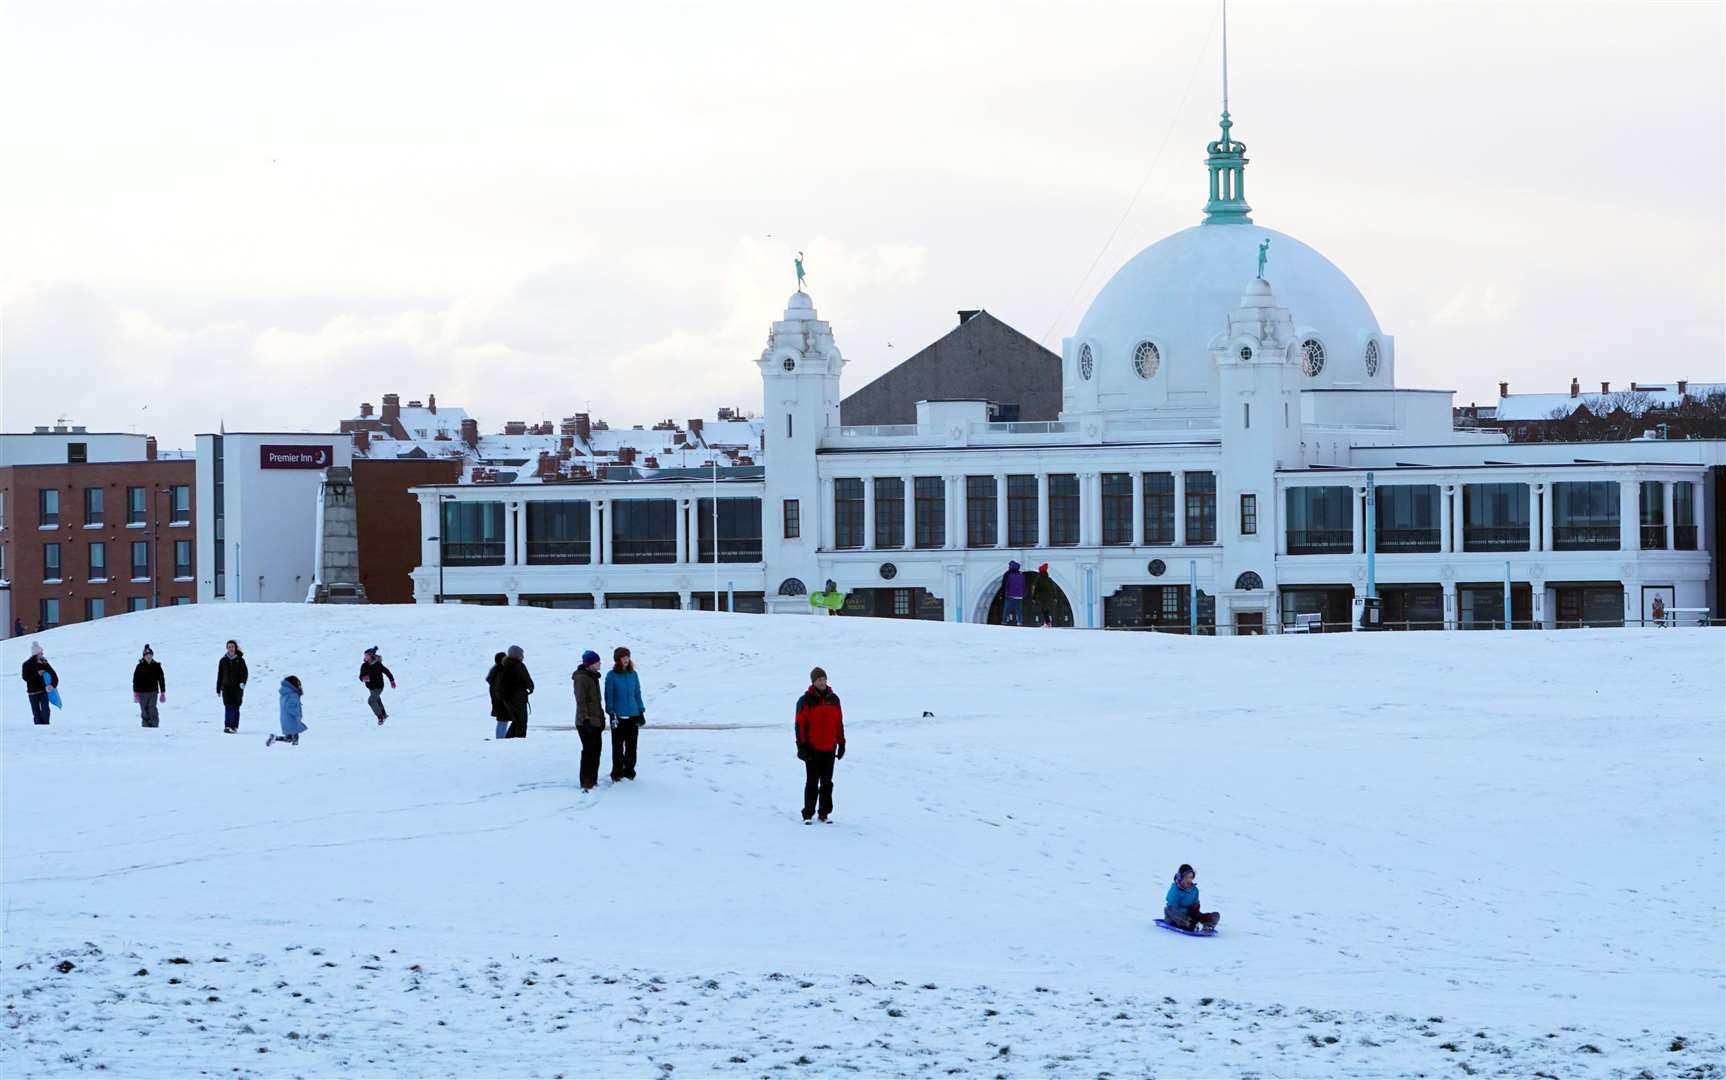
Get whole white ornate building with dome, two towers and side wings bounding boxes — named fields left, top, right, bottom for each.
left=414, top=112, right=1726, bottom=633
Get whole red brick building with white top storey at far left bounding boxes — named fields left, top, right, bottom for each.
left=0, top=424, right=197, bottom=633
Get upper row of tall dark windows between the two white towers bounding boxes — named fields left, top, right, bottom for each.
left=825, top=473, right=1222, bottom=549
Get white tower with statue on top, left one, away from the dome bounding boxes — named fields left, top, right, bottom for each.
left=756, top=290, right=846, bottom=612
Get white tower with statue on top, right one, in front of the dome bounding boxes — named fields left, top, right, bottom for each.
left=1210, top=278, right=1301, bottom=625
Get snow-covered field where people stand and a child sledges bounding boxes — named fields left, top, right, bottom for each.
left=0, top=606, right=1726, bottom=1077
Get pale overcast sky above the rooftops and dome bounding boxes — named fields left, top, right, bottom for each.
left=0, top=0, right=1726, bottom=447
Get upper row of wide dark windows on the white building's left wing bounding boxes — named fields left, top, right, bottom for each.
left=440, top=499, right=762, bottom=566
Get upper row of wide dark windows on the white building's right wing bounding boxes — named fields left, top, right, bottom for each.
left=1288, top=480, right=1698, bottom=556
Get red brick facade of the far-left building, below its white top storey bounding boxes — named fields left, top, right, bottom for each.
left=0, top=457, right=198, bottom=633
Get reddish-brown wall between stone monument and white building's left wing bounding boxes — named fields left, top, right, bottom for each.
left=354, top=457, right=461, bottom=604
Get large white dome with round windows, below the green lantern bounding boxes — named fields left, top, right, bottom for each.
left=1063, top=224, right=1391, bottom=411
